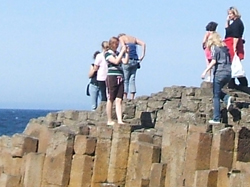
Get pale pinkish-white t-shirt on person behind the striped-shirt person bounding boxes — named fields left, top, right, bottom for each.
left=94, top=52, right=108, bottom=81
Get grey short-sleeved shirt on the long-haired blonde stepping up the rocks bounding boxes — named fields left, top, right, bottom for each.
left=211, top=46, right=231, bottom=76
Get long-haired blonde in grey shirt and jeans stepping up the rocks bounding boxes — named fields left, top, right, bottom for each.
left=201, top=32, right=232, bottom=124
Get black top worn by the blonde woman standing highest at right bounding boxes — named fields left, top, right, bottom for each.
left=225, top=18, right=244, bottom=38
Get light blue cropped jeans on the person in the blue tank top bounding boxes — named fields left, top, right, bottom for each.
left=122, top=59, right=138, bottom=93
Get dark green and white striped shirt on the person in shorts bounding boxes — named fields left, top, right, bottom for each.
left=105, top=50, right=123, bottom=76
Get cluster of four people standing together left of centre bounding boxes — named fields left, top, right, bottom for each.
left=89, top=34, right=146, bottom=125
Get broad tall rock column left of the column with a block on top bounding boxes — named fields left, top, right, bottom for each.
left=42, top=128, right=75, bottom=187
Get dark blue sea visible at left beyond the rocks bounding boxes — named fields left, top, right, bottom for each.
left=0, top=109, right=55, bottom=136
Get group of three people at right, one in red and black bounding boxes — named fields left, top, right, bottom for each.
left=201, top=7, right=248, bottom=124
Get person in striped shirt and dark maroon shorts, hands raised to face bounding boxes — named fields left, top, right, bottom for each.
left=105, top=37, right=129, bottom=125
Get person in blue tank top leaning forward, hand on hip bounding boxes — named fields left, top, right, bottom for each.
left=118, top=33, right=146, bottom=99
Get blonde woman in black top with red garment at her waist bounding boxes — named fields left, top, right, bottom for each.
left=224, top=7, right=248, bottom=88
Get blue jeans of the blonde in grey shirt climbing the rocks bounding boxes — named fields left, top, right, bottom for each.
left=213, top=75, right=231, bottom=121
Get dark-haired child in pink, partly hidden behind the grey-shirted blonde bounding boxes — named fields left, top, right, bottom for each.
left=202, top=21, right=218, bottom=82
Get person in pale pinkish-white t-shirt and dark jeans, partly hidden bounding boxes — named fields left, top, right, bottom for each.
left=94, top=41, right=109, bottom=101
